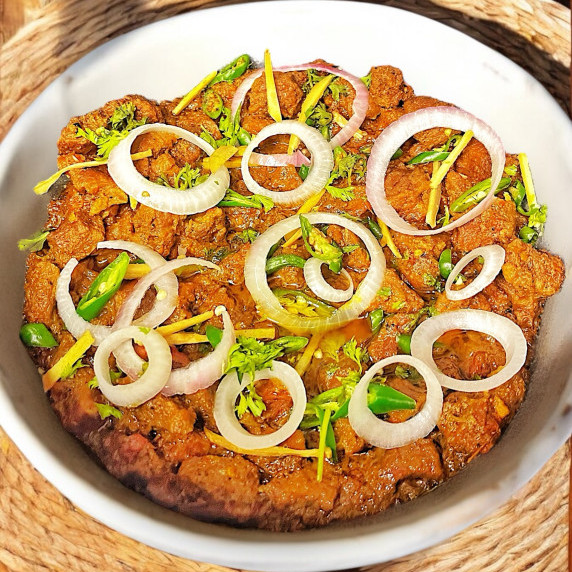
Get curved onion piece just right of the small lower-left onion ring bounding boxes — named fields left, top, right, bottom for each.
left=163, top=306, right=236, bottom=395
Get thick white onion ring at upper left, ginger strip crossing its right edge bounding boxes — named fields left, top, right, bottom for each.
left=107, top=123, right=230, bottom=215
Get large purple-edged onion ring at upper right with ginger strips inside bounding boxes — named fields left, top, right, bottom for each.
left=366, top=107, right=505, bottom=236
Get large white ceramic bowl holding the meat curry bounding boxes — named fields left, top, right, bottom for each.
left=0, top=2, right=572, bottom=571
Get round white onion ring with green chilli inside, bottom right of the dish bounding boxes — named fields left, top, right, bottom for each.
left=348, top=355, right=443, bottom=449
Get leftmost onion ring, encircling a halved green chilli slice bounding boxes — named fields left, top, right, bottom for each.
left=56, top=240, right=178, bottom=346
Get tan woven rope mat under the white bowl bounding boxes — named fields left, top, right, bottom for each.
left=0, top=0, right=570, bottom=572
